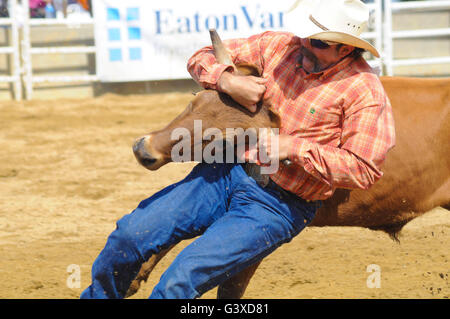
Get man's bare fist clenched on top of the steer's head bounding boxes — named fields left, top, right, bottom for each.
left=217, top=72, right=267, bottom=112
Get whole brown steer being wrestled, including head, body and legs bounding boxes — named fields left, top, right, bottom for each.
left=127, top=31, right=450, bottom=298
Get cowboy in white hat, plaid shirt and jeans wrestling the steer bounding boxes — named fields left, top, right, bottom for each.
left=82, top=0, right=394, bottom=298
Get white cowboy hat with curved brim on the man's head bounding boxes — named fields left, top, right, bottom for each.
left=286, top=0, right=380, bottom=57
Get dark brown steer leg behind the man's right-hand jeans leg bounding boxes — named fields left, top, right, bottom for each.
left=217, top=262, right=261, bottom=299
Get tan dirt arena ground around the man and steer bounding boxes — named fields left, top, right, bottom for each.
left=0, top=94, right=450, bottom=299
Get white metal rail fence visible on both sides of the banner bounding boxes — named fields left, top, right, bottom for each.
left=0, top=0, right=450, bottom=100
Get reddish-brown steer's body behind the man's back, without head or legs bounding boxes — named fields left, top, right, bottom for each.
left=311, top=77, right=450, bottom=237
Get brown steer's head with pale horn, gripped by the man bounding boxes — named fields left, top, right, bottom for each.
left=133, top=30, right=280, bottom=170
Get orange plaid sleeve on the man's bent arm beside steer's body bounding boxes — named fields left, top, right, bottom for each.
left=289, top=75, right=395, bottom=189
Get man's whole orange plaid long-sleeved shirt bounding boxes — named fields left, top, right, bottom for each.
left=188, top=31, right=395, bottom=200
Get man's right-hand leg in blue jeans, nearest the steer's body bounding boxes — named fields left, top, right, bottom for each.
left=150, top=178, right=317, bottom=299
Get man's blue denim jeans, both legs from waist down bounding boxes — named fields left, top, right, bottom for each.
left=81, top=164, right=318, bottom=299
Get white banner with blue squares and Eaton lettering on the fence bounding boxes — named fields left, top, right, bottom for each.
left=92, top=0, right=295, bottom=82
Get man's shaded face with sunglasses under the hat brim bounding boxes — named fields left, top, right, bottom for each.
left=301, top=38, right=353, bottom=73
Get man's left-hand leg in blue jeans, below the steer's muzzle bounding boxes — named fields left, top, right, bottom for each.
left=81, top=164, right=239, bottom=298
